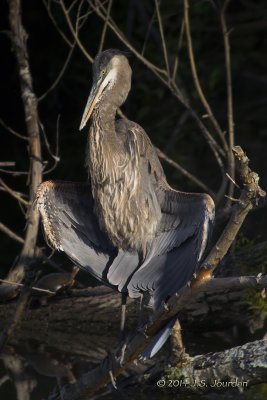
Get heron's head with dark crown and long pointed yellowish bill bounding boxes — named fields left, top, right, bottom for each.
left=80, top=49, right=132, bottom=130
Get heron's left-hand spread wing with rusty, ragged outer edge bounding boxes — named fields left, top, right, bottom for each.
left=37, top=181, right=116, bottom=283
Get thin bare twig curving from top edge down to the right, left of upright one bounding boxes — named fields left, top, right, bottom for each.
left=184, top=0, right=228, bottom=152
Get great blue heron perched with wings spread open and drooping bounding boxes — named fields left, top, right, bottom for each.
left=37, top=50, right=214, bottom=358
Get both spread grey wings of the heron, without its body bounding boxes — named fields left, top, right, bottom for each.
left=37, top=181, right=214, bottom=308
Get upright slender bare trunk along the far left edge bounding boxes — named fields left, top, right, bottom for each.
left=0, top=0, right=42, bottom=348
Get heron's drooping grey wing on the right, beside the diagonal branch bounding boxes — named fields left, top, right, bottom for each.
left=128, top=188, right=214, bottom=308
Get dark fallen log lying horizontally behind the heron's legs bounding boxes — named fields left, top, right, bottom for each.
left=0, top=276, right=267, bottom=338
